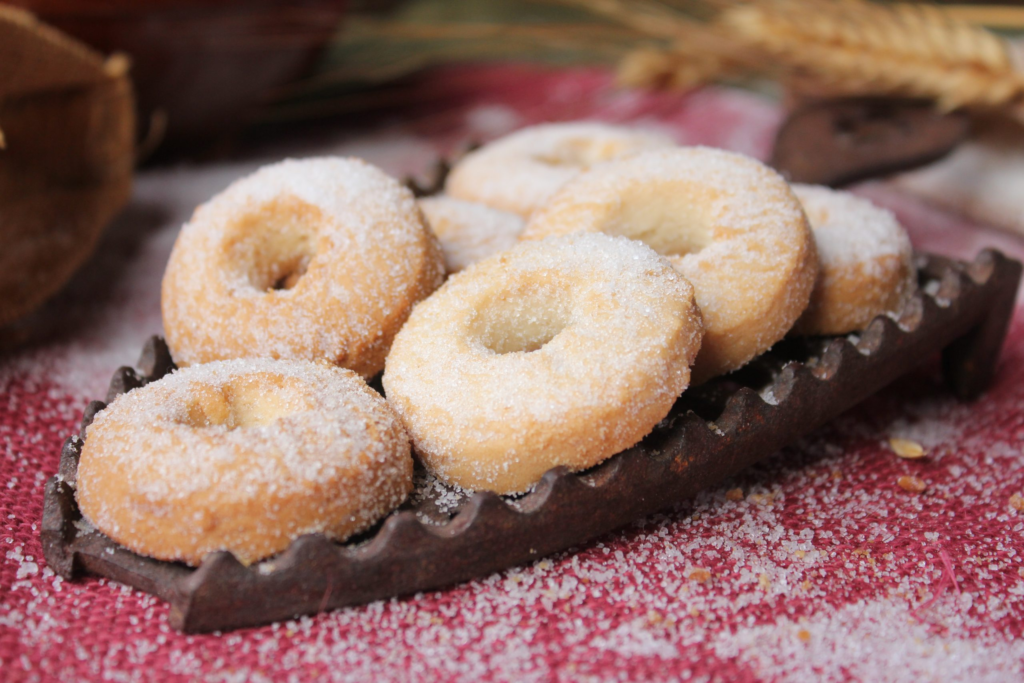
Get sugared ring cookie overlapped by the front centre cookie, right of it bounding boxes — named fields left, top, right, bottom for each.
left=521, top=147, right=817, bottom=384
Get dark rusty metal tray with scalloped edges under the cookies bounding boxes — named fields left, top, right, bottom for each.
left=42, top=251, right=1021, bottom=633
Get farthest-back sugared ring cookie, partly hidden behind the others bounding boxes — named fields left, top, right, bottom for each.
left=444, top=122, right=674, bottom=218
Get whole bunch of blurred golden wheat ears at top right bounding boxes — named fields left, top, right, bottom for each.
left=561, top=0, right=1024, bottom=110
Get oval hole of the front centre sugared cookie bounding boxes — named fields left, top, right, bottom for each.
left=470, top=289, right=569, bottom=354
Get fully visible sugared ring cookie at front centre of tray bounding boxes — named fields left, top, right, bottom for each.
left=383, top=234, right=701, bottom=494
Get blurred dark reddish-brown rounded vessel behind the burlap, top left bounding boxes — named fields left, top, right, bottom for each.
left=8, top=0, right=347, bottom=156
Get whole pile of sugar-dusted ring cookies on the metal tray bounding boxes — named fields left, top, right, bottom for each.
left=77, top=123, right=915, bottom=565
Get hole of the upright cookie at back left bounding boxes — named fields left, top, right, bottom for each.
left=228, top=198, right=326, bottom=292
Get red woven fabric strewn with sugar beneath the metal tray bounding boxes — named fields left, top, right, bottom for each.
left=0, top=68, right=1024, bottom=681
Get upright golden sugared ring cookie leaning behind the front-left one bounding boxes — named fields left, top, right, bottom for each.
left=161, top=158, right=444, bottom=377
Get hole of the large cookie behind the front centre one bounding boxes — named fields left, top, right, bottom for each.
left=600, top=184, right=714, bottom=257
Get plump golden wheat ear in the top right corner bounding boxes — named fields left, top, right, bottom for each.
left=718, top=0, right=1024, bottom=110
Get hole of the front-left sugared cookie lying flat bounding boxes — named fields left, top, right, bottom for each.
left=181, top=378, right=311, bottom=430
